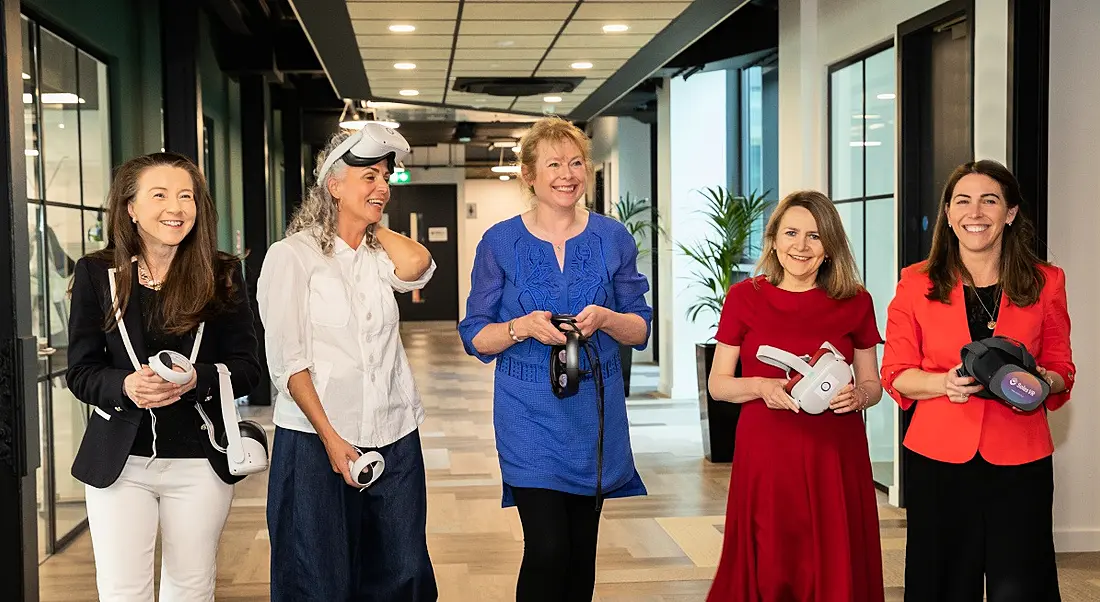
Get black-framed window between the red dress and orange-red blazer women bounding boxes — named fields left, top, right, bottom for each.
left=828, top=47, right=898, bottom=486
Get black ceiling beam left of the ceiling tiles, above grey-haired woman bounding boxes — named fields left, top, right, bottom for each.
left=290, top=0, right=372, bottom=99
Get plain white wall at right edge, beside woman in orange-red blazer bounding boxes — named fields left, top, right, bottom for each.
left=1047, top=0, right=1100, bottom=551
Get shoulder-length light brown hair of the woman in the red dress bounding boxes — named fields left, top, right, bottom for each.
left=756, top=190, right=864, bottom=299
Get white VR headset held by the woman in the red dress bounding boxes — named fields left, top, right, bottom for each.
left=757, top=341, right=851, bottom=414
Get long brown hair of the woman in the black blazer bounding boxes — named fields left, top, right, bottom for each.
left=90, top=153, right=240, bottom=335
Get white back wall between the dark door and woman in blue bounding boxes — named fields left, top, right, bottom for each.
left=459, top=178, right=530, bottom=320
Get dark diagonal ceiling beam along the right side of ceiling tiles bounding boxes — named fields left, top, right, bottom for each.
left=569, top=0, right=748, bottom=121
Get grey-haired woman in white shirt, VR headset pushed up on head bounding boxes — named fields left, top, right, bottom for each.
left=257, top=123, right=437, bottom=602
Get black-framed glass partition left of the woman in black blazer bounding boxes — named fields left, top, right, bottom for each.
left=23, top=18, right=111, bottom=560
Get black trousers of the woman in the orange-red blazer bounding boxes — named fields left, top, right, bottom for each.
left=905, top=452, right=1060, bottom=602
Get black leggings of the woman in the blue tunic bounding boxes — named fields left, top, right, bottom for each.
left=512, top=488, right=600, bottom=602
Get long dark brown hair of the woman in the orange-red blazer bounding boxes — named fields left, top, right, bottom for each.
left=924, top=160, right=1046, bottom=307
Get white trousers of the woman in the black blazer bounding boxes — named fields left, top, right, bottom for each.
left=85, top=456, right=233, bottom=602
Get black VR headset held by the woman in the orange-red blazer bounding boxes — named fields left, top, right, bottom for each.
left=956, top=336, right=1051, bottom=412
